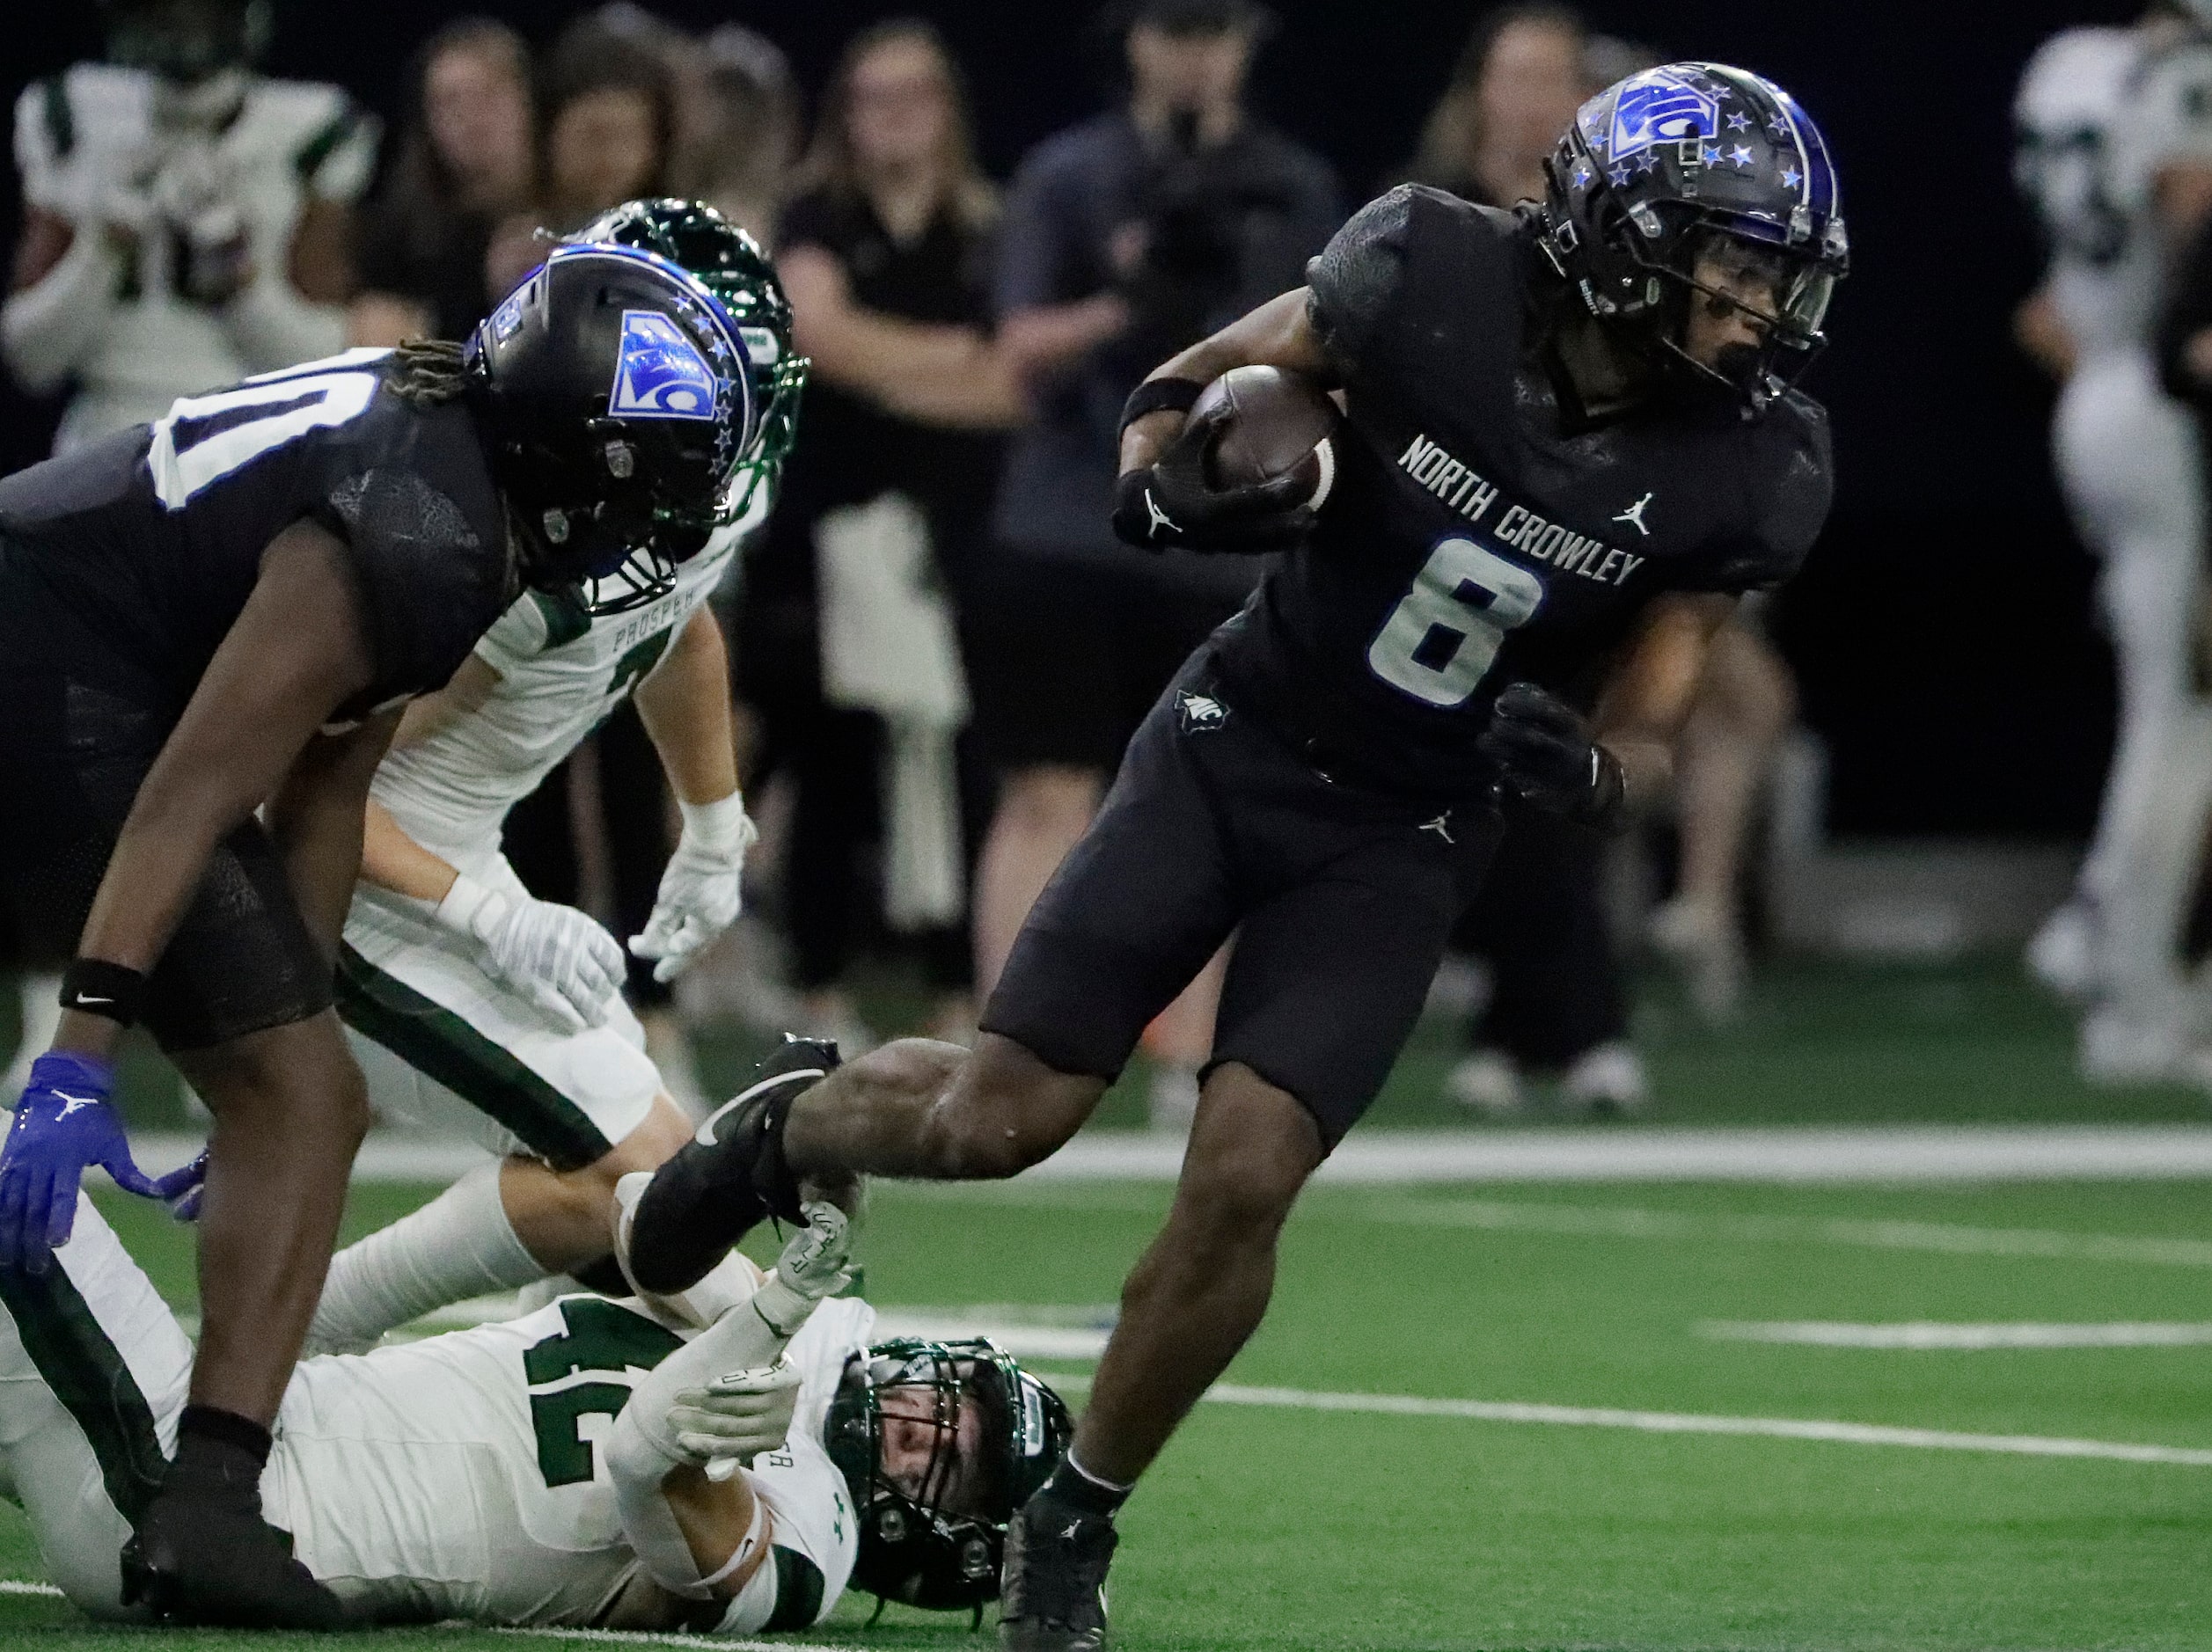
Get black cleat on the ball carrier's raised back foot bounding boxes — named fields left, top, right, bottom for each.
left=628, top=1035, right=839, bottom=1296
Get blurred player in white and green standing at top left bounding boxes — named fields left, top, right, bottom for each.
left=0, top=0, right=376, bottom=1106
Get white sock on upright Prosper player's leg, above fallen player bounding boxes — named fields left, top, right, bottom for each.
left=307, top=1163, right=546, bottom=1354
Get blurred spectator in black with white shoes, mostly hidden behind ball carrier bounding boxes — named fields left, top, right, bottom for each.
left=1409, top=4, right=1648, bottom=1117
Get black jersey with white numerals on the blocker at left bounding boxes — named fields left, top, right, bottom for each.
left=0, top=349, right=513, bottom=717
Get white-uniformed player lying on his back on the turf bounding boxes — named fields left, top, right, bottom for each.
left=0, top=1199, right=1068, bottom=1634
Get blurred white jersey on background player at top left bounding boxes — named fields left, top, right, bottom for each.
left=16, top=62, right=376, bottom=451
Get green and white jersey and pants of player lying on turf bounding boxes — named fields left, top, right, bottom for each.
left=0, top=1196, right=858, bottom=1634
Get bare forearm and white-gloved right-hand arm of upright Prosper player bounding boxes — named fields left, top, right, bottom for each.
left=630, top=608, right=758, bottom=982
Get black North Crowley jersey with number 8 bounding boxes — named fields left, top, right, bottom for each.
left=1214, top=186, right=1832, bottom=799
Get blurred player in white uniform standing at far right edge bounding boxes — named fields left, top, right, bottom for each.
left=2015, top=13, right=2212, bottom=1081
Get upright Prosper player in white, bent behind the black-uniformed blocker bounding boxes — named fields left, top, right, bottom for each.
left=310, top=201, right=805, bottom=1351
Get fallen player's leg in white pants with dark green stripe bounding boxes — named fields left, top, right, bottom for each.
left=0, top=1195, right=193, bottom=1619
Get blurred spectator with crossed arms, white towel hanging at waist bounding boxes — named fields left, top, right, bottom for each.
left=736, top=20, right=1022, bottom=1053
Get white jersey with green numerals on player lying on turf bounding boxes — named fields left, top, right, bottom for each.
left=261, top=1296, right=876, bottom=1632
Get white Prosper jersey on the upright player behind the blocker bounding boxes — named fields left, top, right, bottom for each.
left=374, top=497, right=772, bottom=872
